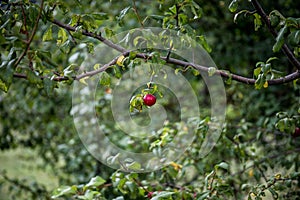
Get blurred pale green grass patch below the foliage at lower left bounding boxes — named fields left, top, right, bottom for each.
left=0, top=148, right=58, bottom=200
